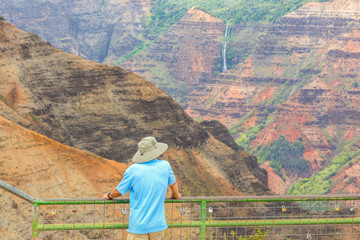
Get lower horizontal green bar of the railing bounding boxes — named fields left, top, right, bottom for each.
left=36, top=218, right=360, bottom=231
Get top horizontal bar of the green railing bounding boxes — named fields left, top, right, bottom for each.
left=36, top=194, right=360, bottom=205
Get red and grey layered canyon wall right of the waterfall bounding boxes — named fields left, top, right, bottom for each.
left=149, top=0, right=360, bottom=193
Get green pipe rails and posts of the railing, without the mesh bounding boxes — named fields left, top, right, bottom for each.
left=33, top=195, right=360, bottom=240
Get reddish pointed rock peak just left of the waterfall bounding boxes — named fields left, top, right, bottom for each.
left=121, top=8, right=225, bottom=99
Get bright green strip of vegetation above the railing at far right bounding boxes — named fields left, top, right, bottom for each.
left=288, top=138, right=360, bottom=195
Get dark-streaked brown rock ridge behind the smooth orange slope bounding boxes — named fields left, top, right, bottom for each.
left=0, top=22, right=268, bottom=199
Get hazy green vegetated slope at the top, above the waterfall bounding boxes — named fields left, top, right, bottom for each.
left=145, top=0, right=327, bottom=39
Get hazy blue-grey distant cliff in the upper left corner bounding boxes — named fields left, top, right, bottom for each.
left=0, top=0, right=150, bottom=63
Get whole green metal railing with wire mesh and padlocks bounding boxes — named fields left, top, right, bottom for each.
left=0, top=181, right=360, bottom=240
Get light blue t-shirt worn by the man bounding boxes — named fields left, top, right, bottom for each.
left=116, top=159, right=175, bottom=234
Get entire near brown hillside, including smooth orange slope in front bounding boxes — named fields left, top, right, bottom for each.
left=0, top=21, right=272, bottom=239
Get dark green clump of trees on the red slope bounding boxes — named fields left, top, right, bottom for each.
left=253, top=134, right=309, bottom=177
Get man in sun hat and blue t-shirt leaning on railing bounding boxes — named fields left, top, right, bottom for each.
left=103, top=137, right=181, bottom=240
